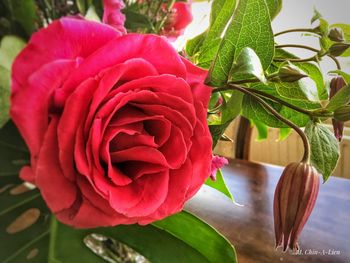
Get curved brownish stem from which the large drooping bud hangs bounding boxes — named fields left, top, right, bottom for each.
left=227, top=86, right=310, bottom=163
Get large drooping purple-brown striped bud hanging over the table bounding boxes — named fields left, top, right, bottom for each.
left=273, top=162, right=320, bottom=251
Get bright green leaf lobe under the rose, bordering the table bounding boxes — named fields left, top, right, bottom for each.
left=153, top=211, right=237, bottom=262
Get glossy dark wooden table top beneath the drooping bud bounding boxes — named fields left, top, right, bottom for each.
left=186, top=160, right=350, bottom=263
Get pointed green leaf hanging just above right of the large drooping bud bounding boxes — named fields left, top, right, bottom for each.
left=305, top=121, right=340, bottom=182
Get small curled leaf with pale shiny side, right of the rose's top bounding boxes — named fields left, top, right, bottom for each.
left=228, top=47, right=266, bottom=83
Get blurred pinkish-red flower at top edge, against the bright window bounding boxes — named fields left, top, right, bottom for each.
left=162, top=2, right=193, bottom=39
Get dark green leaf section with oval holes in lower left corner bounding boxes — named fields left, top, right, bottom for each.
left=0, top=122, right=49, bottom=263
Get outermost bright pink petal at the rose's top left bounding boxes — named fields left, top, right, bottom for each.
left=12, top=18, right=118, bottom=93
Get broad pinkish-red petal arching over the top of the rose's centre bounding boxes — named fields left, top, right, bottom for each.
left=58, top=34, right=186, bottom=93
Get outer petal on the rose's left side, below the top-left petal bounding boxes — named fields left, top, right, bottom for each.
left=10, top=59, right=76, bottom=169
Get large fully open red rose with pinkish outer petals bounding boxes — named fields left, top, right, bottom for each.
left=11, top=18, right=212, bottom=228
